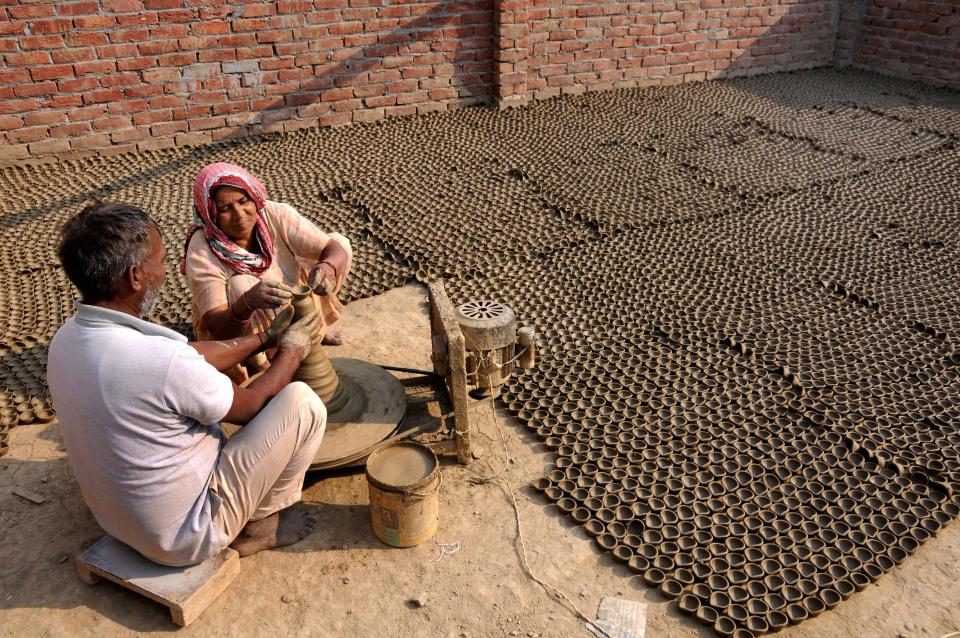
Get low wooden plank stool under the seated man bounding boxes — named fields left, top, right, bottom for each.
left=77, top=535, right=240, bottom=627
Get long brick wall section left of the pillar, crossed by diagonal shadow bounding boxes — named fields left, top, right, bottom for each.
left=0, top=0, right=493, bottom=164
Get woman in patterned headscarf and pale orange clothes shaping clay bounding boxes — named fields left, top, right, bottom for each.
left=180, top=162, right=353, bottom=383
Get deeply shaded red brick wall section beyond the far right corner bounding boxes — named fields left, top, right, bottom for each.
left=852, top=0, right=960, bottom=87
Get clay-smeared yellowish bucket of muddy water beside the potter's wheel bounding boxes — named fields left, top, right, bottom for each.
left=367, top=441, right=443, bottom=547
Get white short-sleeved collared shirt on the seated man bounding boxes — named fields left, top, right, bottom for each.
left=47, top=303, right=233, bottom=565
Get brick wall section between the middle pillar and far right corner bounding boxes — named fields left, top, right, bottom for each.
left=527, top=0, right=836, bottom=97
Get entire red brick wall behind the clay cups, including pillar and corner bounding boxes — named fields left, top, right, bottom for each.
left=0, top=0, right=960, bottom=166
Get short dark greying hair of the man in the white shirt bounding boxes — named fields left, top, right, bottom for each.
left=59, top=202, right=156, bottom=301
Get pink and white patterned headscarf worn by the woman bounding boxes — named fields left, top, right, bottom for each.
left=180, top=162, right=276, bottom=275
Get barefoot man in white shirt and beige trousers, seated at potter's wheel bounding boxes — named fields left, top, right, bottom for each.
left=47, top=203, right=327, bottom=566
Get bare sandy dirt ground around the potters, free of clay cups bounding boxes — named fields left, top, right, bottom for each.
left=0, top=285, right=960, bottom=638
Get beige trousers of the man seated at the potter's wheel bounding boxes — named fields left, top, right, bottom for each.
left=211, top=381, right=327, bottom=542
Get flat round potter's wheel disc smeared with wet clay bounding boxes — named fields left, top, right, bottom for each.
left=310, top=358, right=407, bottom=470
